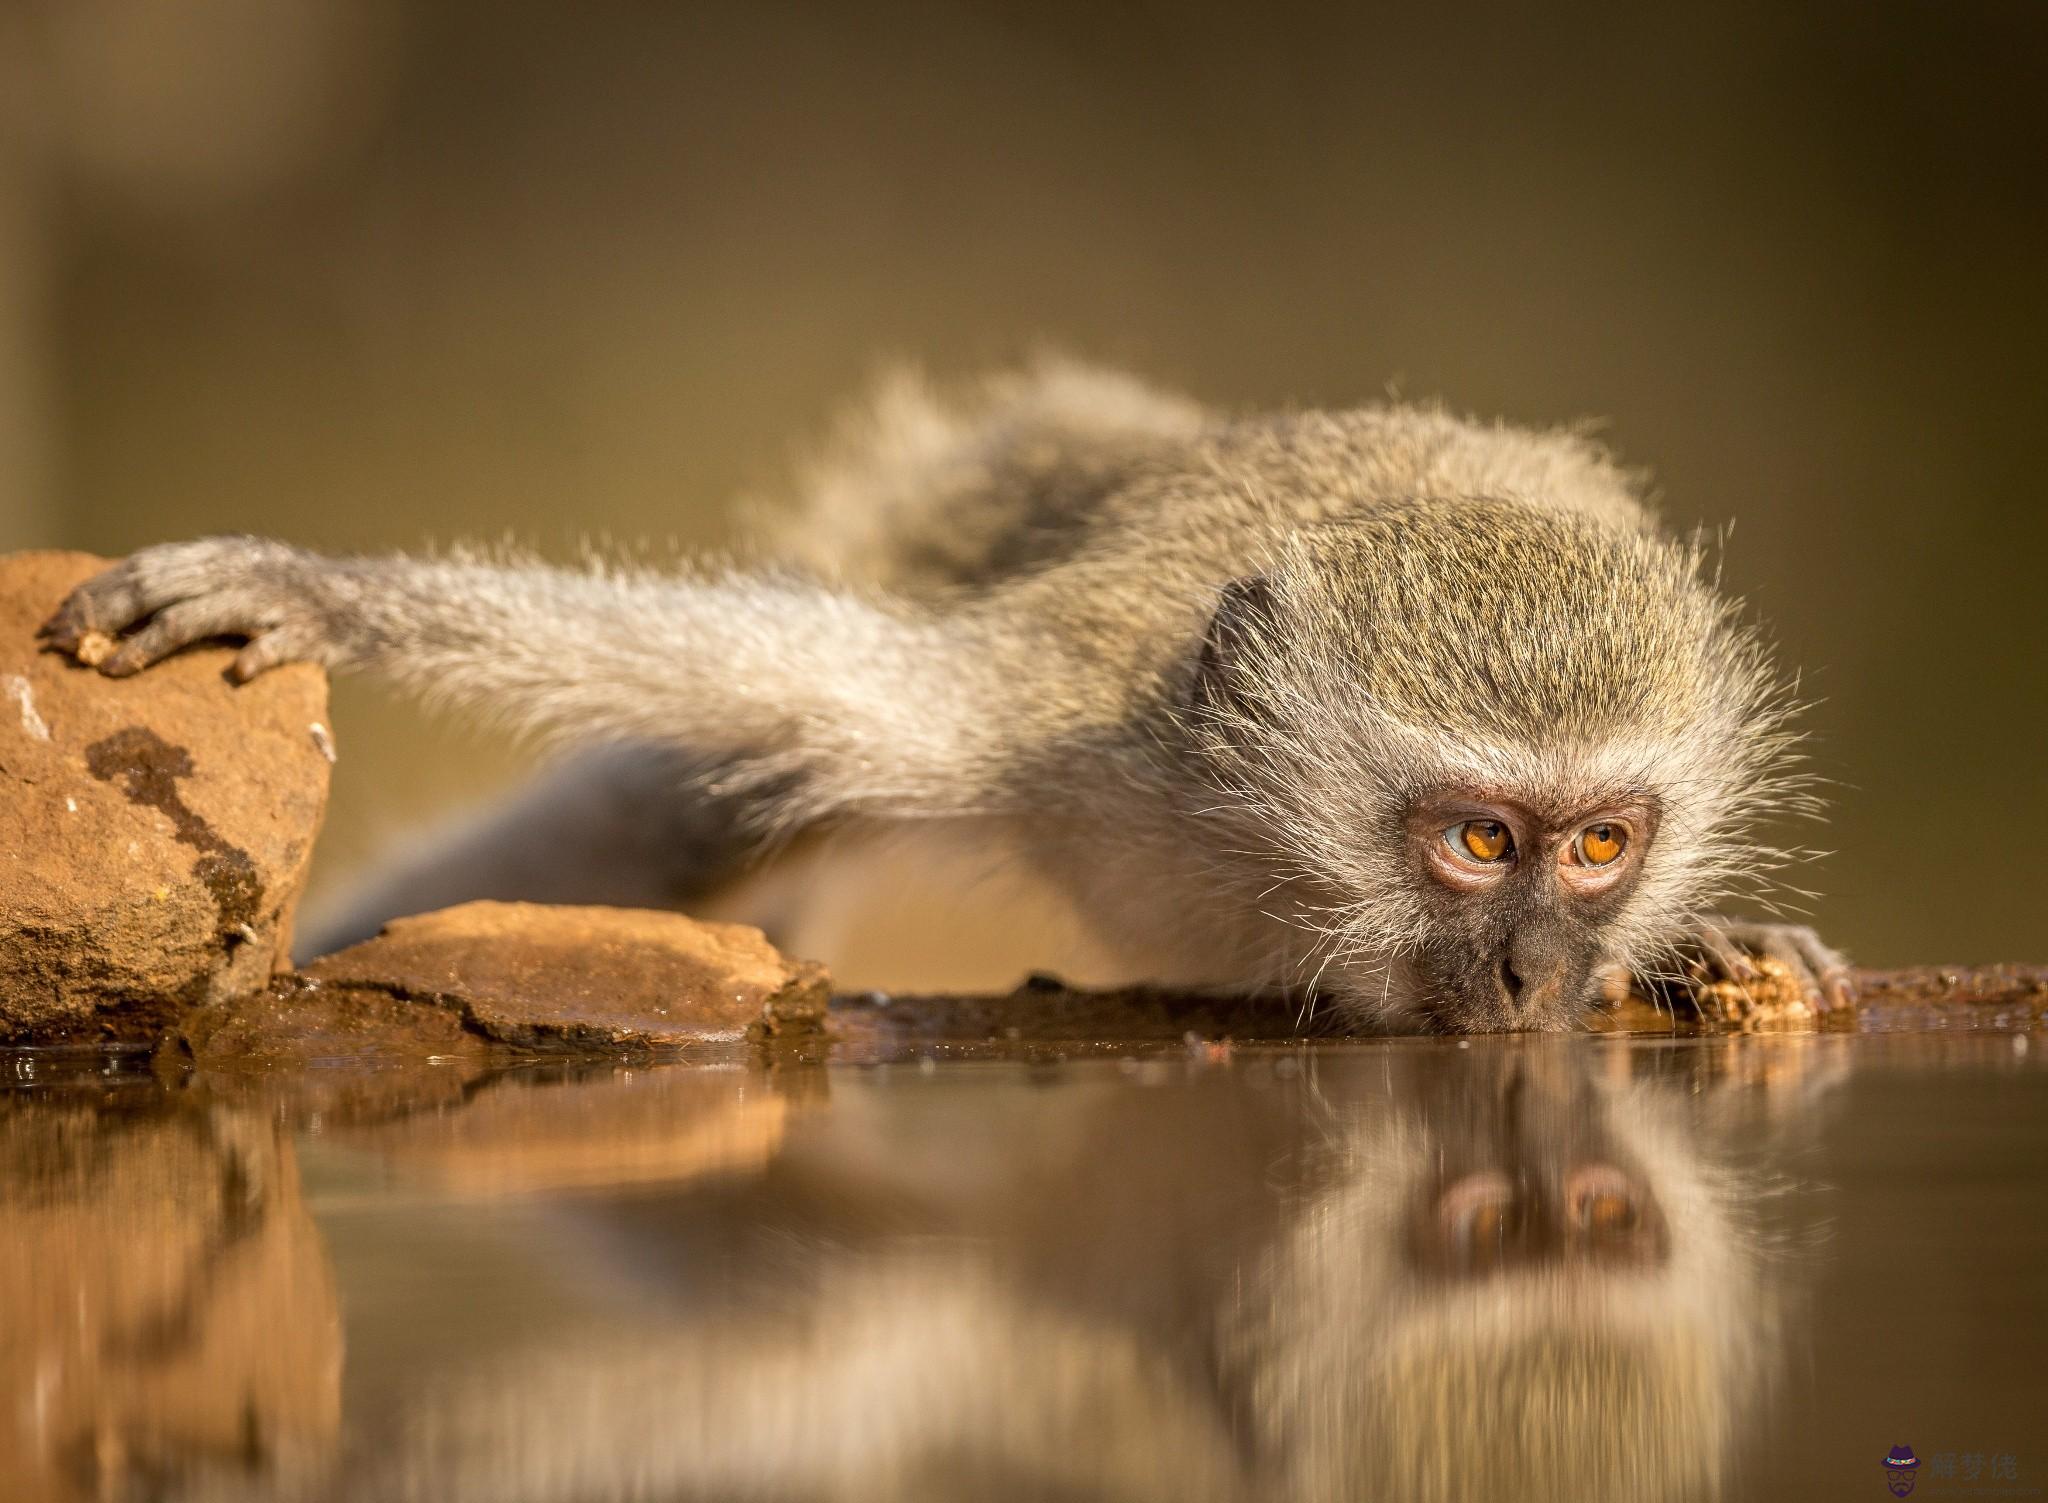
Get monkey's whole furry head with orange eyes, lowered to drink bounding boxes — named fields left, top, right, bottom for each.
left=1184, top=500, right=1798, bottom=1030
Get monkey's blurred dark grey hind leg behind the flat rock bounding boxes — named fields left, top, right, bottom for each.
left=293, top=743, right=756, bottom=960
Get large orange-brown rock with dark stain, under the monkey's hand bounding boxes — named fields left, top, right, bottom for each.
left=0, top=553, right=330, bottom=1040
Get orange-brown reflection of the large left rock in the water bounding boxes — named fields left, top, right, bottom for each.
left=0, top=1085, right=342, bottom=1503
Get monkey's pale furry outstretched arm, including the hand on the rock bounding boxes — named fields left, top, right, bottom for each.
left=43, top=536, right=1028, bottom=813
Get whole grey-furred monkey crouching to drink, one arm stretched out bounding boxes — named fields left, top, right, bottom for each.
left=43, top=360, right=1847, bottom=1032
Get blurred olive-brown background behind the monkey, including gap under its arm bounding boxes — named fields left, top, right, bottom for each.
left=0, top=0, right=2048, bottom=962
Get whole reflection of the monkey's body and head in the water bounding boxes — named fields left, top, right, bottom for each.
left=323, top=1040, right=1826, bottom=1499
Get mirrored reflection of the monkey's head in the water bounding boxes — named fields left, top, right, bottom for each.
left=1233, top=1053, right=1778, bottom=1499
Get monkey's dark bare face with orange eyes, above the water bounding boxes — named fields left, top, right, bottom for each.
left=1407, top=788, right=1657, bottom=1032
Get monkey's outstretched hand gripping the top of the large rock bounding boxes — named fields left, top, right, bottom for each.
left=41, top=536, right=373, bottom=682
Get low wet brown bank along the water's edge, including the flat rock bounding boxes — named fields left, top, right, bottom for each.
left=123, top=954, right=2048, bottom=1085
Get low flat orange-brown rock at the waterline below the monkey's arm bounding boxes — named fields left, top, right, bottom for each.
left=303, top=903, right=827, bottom=1048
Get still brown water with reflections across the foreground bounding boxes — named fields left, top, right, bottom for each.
left=0, top=1032, right=2048, bottom=1503
